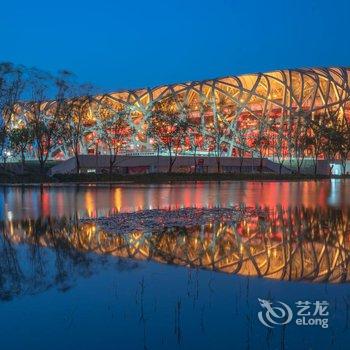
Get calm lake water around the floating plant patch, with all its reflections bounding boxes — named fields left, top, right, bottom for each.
left=0, top=180, right=350, bottom=349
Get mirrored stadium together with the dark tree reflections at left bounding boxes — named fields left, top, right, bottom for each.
left=0, top=206, right=350, bottom=299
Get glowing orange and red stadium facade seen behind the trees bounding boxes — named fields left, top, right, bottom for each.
left=12, top=68, right=350, bottom=165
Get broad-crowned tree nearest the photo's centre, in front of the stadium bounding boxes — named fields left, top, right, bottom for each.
left=147, top=99, right=190, bottom=173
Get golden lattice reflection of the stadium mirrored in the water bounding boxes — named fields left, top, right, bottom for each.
left=0, top=206, right=350, bottom=288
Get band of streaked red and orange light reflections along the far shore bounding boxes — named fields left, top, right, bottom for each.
left=0, top=180, right=350, bottom=219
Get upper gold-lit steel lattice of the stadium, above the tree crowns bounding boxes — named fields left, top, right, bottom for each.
left=10, top=68, right=350, bottom=158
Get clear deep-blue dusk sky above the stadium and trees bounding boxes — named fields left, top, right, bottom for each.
left=0, top=0, right=350, bottom=91
